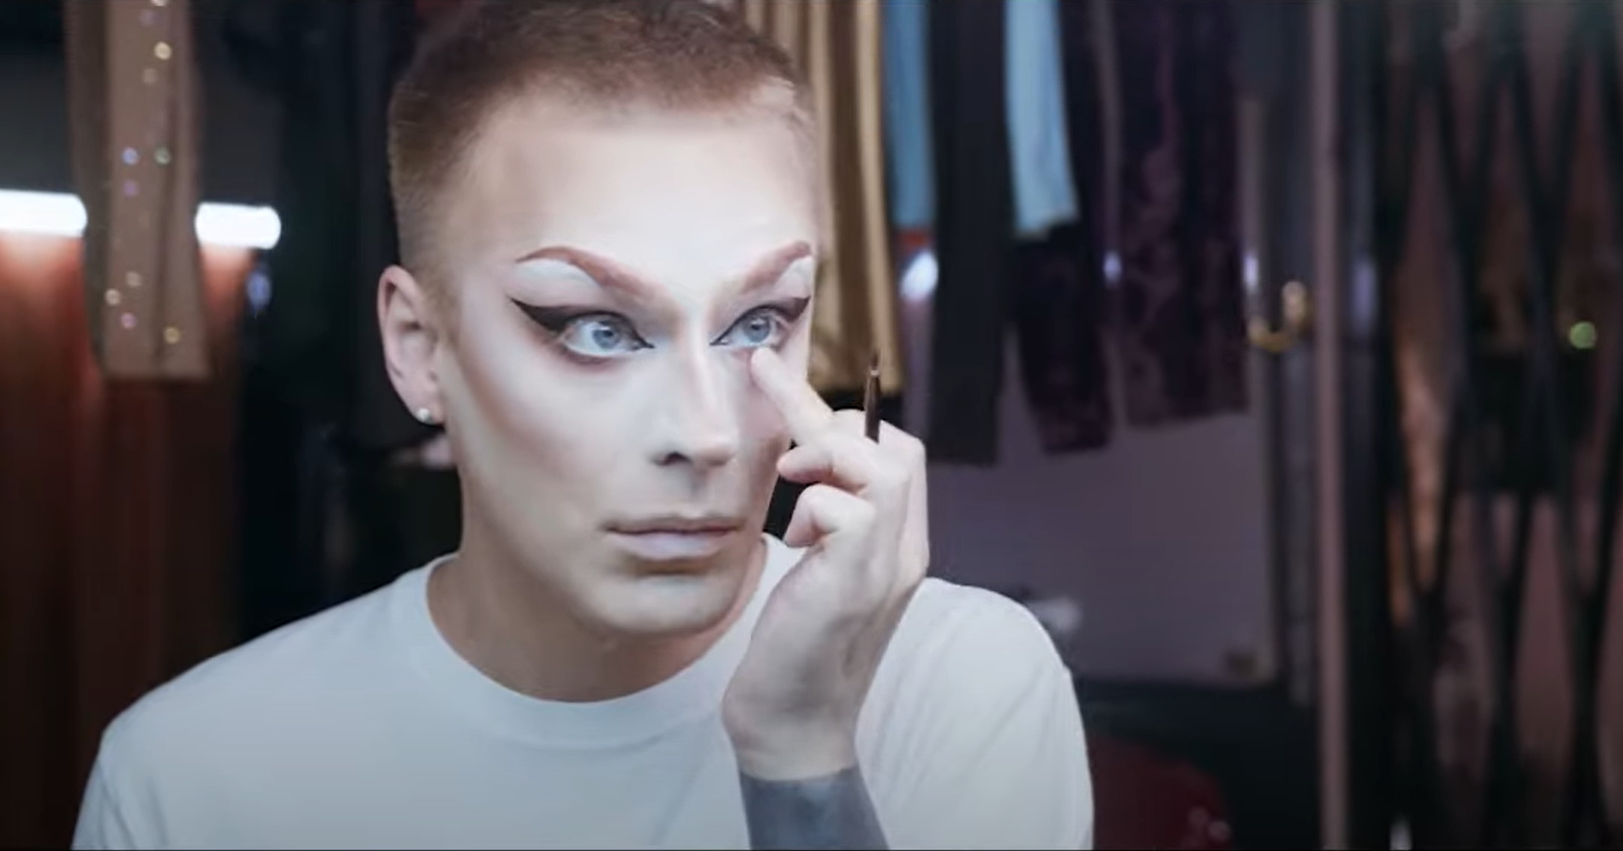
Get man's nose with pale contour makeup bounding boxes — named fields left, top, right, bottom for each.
left=652, top=343, right=742, bottom=469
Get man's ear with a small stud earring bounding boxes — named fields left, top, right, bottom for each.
left=378, top=266, right=445, bottom=424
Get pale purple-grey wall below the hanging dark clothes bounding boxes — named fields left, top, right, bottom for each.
left=902, top=289, right=1274, bottom=685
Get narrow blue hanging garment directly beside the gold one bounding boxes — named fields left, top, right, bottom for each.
left=883, top=0, right=935, bottom=232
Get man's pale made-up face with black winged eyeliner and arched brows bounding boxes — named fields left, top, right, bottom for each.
left=374, top=92, right=818, bottom=635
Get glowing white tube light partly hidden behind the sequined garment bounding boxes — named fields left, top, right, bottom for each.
left=0, top=190, right=282, bottom=248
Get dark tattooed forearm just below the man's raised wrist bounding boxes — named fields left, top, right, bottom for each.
left=738, top=767, right=886, bottom=849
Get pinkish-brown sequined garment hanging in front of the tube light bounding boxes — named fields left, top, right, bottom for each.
left=65, top=0, right=209, bottom=378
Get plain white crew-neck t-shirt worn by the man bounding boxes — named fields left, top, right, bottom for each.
left=73, top=538, right=1092, bottom=848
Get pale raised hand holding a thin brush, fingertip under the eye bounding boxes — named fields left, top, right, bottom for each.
left=722, top=349, right=930, bottom=781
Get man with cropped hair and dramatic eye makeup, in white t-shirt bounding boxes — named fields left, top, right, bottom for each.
left=75, top=0, right=1092, bottom=848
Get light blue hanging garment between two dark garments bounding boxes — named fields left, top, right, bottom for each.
left=1003, top=0, right=1076, bottom=239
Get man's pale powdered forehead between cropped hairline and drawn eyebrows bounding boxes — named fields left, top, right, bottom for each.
left=441, top=97, right=820, bottom=285
